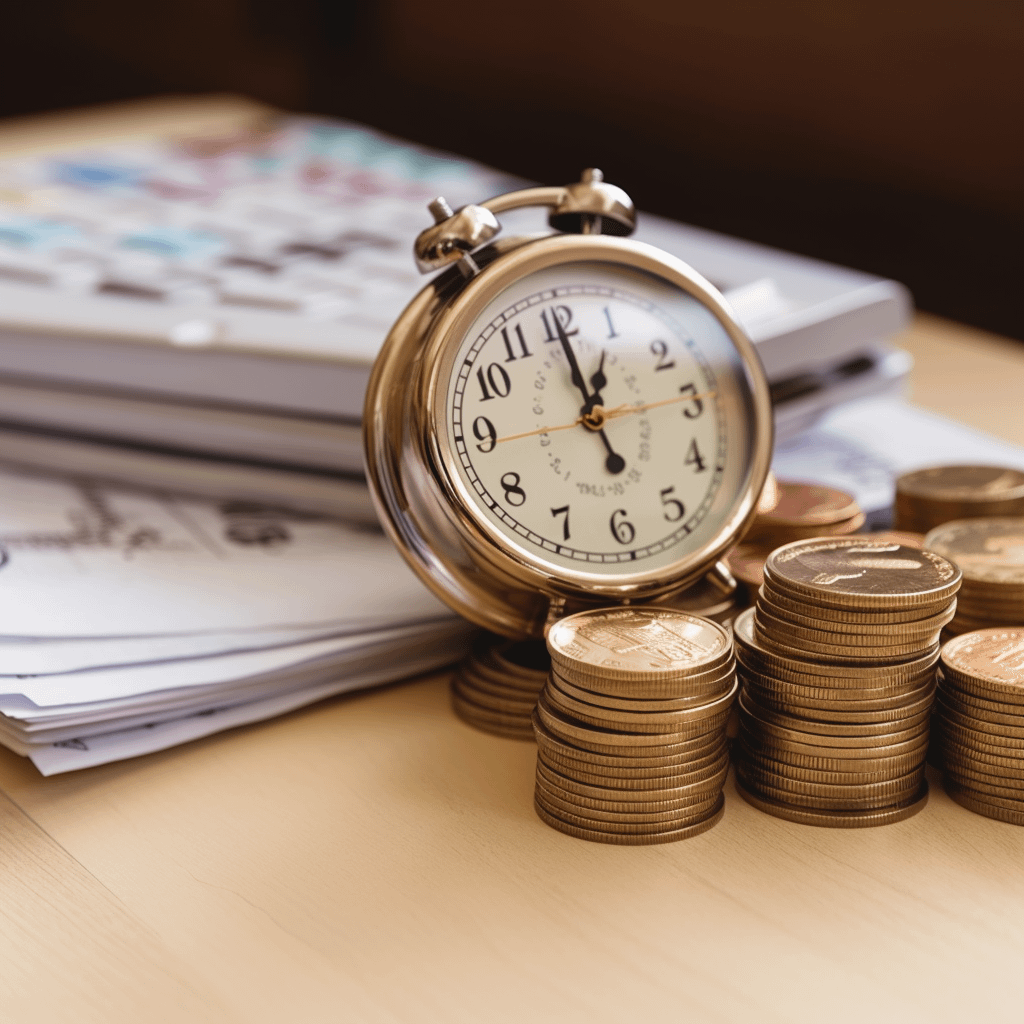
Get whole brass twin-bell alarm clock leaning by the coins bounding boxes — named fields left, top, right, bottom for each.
left=364, top=170, right=772, bottom=637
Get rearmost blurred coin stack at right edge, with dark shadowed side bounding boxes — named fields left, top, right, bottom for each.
left=895, top=466, right=1024, bottom=534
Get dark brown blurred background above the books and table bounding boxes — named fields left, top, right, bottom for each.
left=0, top=0, right=1024, bottom=339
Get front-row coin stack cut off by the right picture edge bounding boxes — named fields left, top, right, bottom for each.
left=932, top=629, right=1024, bottom=825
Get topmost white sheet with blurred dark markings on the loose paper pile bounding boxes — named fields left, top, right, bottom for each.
left=0, top=472, right=451, bottom=638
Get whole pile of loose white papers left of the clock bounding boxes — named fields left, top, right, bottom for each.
left=0, top=471, right=470, bottom=775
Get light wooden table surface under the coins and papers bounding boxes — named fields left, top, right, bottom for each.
left=0, top=96, right=1024, bottom=1024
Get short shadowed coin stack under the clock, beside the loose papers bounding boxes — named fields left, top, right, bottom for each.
left=452, top=633, right=551, bottom=739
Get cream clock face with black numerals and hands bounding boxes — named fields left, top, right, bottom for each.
left=437, top=261, right=755, bottom=579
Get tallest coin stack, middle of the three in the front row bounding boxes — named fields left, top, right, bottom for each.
left=734, top=538, right=961, bottom=828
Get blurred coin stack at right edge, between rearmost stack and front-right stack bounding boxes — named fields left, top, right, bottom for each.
left=925, top=518, right=1024, bottom=637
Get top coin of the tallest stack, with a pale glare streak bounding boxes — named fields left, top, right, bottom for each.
left=765, top=537, right=961, bottom=608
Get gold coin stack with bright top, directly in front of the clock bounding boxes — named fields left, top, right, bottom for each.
left=534, top=606, right=736, bottom=846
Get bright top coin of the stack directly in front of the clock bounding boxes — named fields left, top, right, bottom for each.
left=548, top=607, right=732, bottom=682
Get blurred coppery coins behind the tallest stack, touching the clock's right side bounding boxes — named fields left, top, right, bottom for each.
left=726, top=480, right=864, bottom=603
